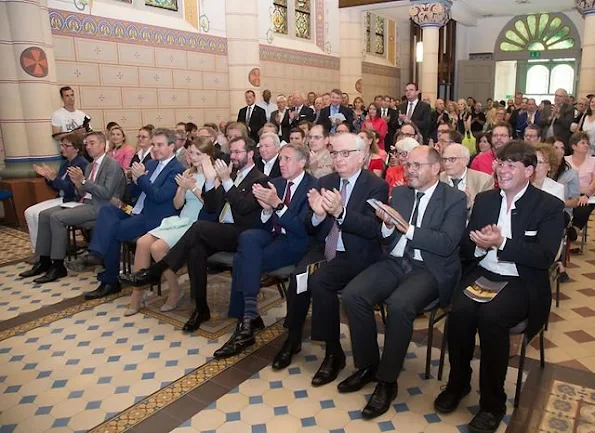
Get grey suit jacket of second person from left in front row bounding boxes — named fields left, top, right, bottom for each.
left=77, top=155, right=126, bottom=211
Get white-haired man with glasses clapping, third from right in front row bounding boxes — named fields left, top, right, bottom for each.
left=273, top=133, right=388, bottom=374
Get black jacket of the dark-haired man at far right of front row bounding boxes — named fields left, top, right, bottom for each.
left=461, top=184, right=564, bottom=338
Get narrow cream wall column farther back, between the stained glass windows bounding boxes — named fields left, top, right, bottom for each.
left=340, top=8, right=363, bottom=101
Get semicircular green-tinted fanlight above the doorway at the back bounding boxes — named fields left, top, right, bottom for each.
left=500, top=14, right=576, bottom=51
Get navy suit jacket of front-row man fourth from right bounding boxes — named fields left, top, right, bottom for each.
left=263, top=173, right=318, bottom=251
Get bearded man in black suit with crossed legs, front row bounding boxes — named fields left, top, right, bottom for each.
left=125, top=137, right=266, bottom=332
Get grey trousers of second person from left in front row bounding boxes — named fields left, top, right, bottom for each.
left=35, top=204, right=98, bottom=260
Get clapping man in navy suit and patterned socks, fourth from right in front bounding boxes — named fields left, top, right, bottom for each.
left=214, top=144, right=318, bottom=358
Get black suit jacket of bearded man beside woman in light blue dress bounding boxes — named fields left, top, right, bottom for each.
left=203, top=167, right=268, bottom=231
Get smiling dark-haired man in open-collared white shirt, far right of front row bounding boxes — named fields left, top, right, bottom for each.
left=434, top=141, right=564, bottom=433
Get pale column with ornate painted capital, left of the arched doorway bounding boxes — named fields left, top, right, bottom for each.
left=409, top=0, right=452, bottom=103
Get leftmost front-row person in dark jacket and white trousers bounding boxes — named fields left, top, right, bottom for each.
left=25, top=134, right=89, bottom=251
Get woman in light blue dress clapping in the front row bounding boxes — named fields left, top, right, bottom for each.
left=124, top=137, right=213, bottom=316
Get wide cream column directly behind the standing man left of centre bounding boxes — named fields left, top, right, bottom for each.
left=225, top=0, right=260, bottom=120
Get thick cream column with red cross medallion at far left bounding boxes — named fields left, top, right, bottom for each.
left=0, top=0, right=60, bottom=178
